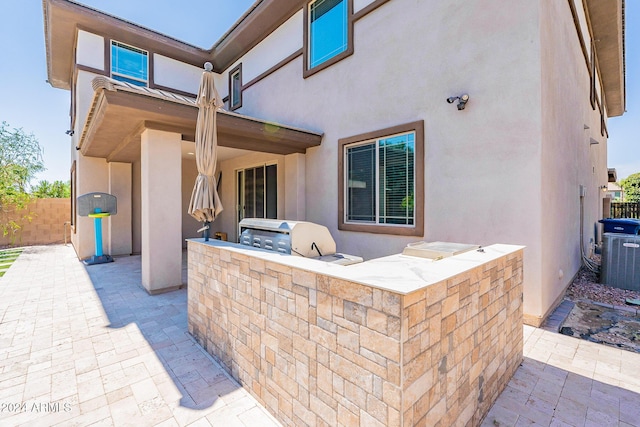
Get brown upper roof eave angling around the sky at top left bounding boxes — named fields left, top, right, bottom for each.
left=42, top=0, right=305, bottom=89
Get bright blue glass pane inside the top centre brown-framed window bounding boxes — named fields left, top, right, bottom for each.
left=309, top=0, right=348, bottom=68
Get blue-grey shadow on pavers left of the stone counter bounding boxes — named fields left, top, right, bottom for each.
left=86, top=253, right=240, bottom=408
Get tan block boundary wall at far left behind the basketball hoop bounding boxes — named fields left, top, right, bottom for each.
left=0, top=198, right=71, bottom=246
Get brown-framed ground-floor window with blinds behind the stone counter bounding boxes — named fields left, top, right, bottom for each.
left=338, top=122, right=424, bottom=235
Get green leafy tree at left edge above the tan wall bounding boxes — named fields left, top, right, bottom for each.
left=0, top=121, right=45, bottom=240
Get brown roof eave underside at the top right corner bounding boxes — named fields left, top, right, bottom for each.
left=586, top=0, right=626, bottom=117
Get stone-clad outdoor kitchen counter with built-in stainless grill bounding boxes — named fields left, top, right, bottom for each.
left=188, top=219, right=523, bottom=426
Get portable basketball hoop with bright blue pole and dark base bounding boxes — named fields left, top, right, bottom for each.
left=78, top=193, right=117, bottom=265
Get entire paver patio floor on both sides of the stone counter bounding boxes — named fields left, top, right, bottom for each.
left=0, top=245, right=640, bottom=427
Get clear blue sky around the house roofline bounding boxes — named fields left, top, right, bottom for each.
left=0, top=0, right=640, bottom=186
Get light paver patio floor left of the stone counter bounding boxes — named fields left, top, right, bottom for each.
left=0, top=245, right=279, bottom=426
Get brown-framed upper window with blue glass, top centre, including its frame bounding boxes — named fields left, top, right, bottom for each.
left=305, top=0, right=353, bottom=75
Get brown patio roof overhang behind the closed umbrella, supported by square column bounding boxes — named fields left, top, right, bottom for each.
left=77, top=77, right=322, bottom=162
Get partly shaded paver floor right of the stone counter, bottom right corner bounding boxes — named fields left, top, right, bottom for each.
left=482, top=326, right=640, bottom=427
